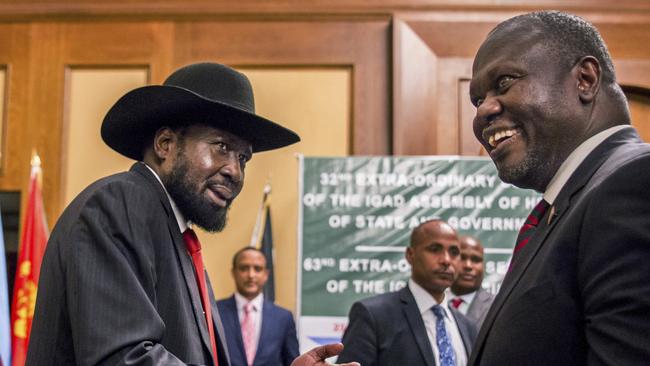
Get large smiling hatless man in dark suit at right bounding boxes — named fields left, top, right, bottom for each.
left=469, top=12, right=650, bottom=366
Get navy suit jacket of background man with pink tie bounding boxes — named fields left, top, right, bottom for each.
left=217, top=295, right=299, bottom=366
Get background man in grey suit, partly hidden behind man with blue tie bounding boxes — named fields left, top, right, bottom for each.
left=449, top=235, right=494, bottom=329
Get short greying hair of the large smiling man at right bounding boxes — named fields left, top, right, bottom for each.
left=490, top=10, right=616, bottom=83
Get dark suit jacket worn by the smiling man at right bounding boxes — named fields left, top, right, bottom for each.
left=469, top=128, right=650, bottom=366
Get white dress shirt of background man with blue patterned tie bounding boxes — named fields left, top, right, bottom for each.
left=408, top=279, right=467, bottom=366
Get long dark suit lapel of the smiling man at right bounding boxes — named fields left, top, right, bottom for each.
left=468, top=129, right=638, bottom=365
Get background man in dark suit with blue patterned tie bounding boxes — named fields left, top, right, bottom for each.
left=339, top=220, right=476, bottom=366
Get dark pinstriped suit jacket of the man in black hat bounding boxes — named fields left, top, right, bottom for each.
left=27, top=163, right=228, bottom=366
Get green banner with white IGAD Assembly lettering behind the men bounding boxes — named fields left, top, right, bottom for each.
left=298, top=157, right=540, bottom=348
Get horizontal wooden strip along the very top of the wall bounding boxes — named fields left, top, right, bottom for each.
left=0, top=0, right=650, bottom=18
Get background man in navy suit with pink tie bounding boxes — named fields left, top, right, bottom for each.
left=217, top=247, right=299, bottom=366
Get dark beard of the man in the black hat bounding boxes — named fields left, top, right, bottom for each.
left=160, top=151, right=230, bottom=232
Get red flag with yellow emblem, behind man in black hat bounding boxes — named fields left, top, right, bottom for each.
left=11, top=154, right=48, bottom=366
